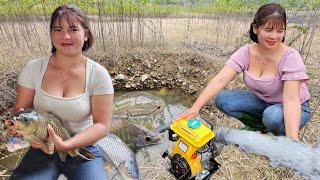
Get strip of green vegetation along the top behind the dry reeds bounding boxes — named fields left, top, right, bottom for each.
left=0, top=0, right=320, bottom=16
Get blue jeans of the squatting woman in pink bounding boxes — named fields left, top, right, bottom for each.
left=215, top=90, right=311, bottom=135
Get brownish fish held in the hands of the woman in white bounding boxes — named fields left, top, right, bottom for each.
left=5, top=109, right=94, bottom=161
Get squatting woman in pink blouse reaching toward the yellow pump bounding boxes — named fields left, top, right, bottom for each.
left=180, top=3, right=311, bottom=140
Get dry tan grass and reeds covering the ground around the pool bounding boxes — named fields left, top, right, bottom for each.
left=0, top=10, right=320, bottom=179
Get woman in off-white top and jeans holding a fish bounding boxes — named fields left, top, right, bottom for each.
left=12, top=5, right=114, bottom=179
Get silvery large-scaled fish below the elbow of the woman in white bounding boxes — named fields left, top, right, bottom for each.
left=96, top=134, right=139, bottom=180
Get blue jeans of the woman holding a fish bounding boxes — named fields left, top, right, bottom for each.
left=10, top=146, right=108, bottom=180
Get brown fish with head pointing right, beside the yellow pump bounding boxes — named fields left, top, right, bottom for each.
left=109, top=119, right=161, bottom=152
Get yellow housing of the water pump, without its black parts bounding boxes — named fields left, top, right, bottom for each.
left=170, top=118, right=214, bottom=176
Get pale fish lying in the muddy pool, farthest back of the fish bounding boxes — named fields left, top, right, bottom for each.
left=113, top=92, right=165, bottom=117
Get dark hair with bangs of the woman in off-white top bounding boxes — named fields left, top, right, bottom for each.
left=50, top=5, right=93, bottom=53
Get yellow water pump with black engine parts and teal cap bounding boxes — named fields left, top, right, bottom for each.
left=162, top=118, right=222, bottom=180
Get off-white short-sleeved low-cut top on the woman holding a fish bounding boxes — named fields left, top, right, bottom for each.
left=18, top=57, right=114, bottom=133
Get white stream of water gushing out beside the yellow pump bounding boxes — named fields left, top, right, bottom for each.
left=216, top=128, right=320, bottom=180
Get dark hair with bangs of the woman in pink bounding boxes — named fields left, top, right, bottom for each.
left=249, top=3, right=287, bottom=43
